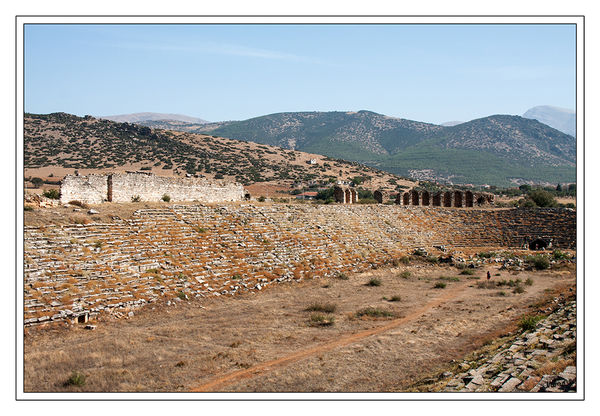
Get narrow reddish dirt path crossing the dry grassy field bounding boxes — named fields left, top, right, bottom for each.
left=191, top=282, right=469, bottom=392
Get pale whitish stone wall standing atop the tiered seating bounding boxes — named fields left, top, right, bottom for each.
left=60, top=173, right=245, bottom=204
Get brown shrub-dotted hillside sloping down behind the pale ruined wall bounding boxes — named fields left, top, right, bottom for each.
left=24, top=113, right=411, bottom=194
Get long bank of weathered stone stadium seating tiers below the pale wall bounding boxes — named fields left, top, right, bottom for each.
left=24, top=204, right=576, bottom=325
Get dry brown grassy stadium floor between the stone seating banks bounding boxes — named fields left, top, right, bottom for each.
left=24, top=264, right=575, bottom=392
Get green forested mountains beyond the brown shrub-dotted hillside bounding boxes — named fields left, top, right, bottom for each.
left=193, top=111, right=576, bottom=186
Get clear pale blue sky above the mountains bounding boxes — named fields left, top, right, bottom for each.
left=25, top=25, right=576, bottom=123
